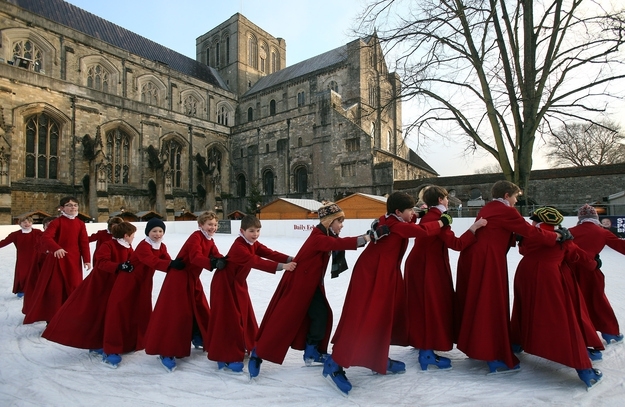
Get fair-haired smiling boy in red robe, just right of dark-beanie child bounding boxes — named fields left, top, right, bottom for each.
left=145, top=212, right=227, bottom=372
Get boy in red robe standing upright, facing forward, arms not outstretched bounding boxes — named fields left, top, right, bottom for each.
left=24, top=196, right=91, bottom=324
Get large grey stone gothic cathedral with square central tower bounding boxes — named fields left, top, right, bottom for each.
left=0, top=0, right=437, bottom=224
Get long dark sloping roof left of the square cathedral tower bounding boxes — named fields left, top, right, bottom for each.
left=8, top=0, right=227, bottom=89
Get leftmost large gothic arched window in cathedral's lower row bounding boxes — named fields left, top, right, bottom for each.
left=26, top=113, right=60, bottom=179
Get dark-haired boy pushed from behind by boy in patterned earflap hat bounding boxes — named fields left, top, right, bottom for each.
left=323, top=192, right=451, bottom=394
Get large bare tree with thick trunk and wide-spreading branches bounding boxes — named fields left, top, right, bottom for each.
left=358, top=0, right=625, bottom=194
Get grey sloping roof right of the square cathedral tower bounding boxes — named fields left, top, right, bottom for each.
left=243, top=45, right=347, bottom=96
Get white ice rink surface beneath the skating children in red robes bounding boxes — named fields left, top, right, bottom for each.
left=0, top=224, right=625, bottom=407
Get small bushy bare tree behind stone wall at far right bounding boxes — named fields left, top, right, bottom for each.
left=546, top=122, right=625, bottom=167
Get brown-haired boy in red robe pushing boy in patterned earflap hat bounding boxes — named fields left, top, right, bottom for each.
left=204, top=215, right=296, bottom=373
